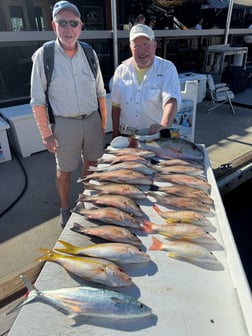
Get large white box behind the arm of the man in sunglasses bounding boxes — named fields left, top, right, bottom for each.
left=0, top=104, right=45, bottom=157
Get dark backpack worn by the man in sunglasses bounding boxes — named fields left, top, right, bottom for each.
left=43, top=41, right=97, bottom=124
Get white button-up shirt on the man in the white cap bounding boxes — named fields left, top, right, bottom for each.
left=111, top=56, right=181, bottom=129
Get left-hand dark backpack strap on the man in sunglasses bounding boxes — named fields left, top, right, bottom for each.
left=43, top=41, right=55, bottom=124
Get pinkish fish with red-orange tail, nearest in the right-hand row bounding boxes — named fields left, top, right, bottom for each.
left=149, top=237, right=223, bottom=270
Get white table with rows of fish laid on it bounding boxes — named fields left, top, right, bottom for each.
left=9, top=148, right=252, bottom=336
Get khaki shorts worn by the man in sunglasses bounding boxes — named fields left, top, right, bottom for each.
left=53, top=111, right=104, bottom=172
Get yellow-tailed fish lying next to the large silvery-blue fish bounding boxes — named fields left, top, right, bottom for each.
left=37, top=248, right=132, bottom=287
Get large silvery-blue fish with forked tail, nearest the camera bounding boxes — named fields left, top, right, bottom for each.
left=8, top=276, right=152, bottom=319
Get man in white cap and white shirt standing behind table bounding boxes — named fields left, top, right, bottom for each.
left=111, top=24, right=181, bottom=137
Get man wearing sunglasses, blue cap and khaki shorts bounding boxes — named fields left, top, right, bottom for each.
left=31, top=1, right=107, bottom=226
